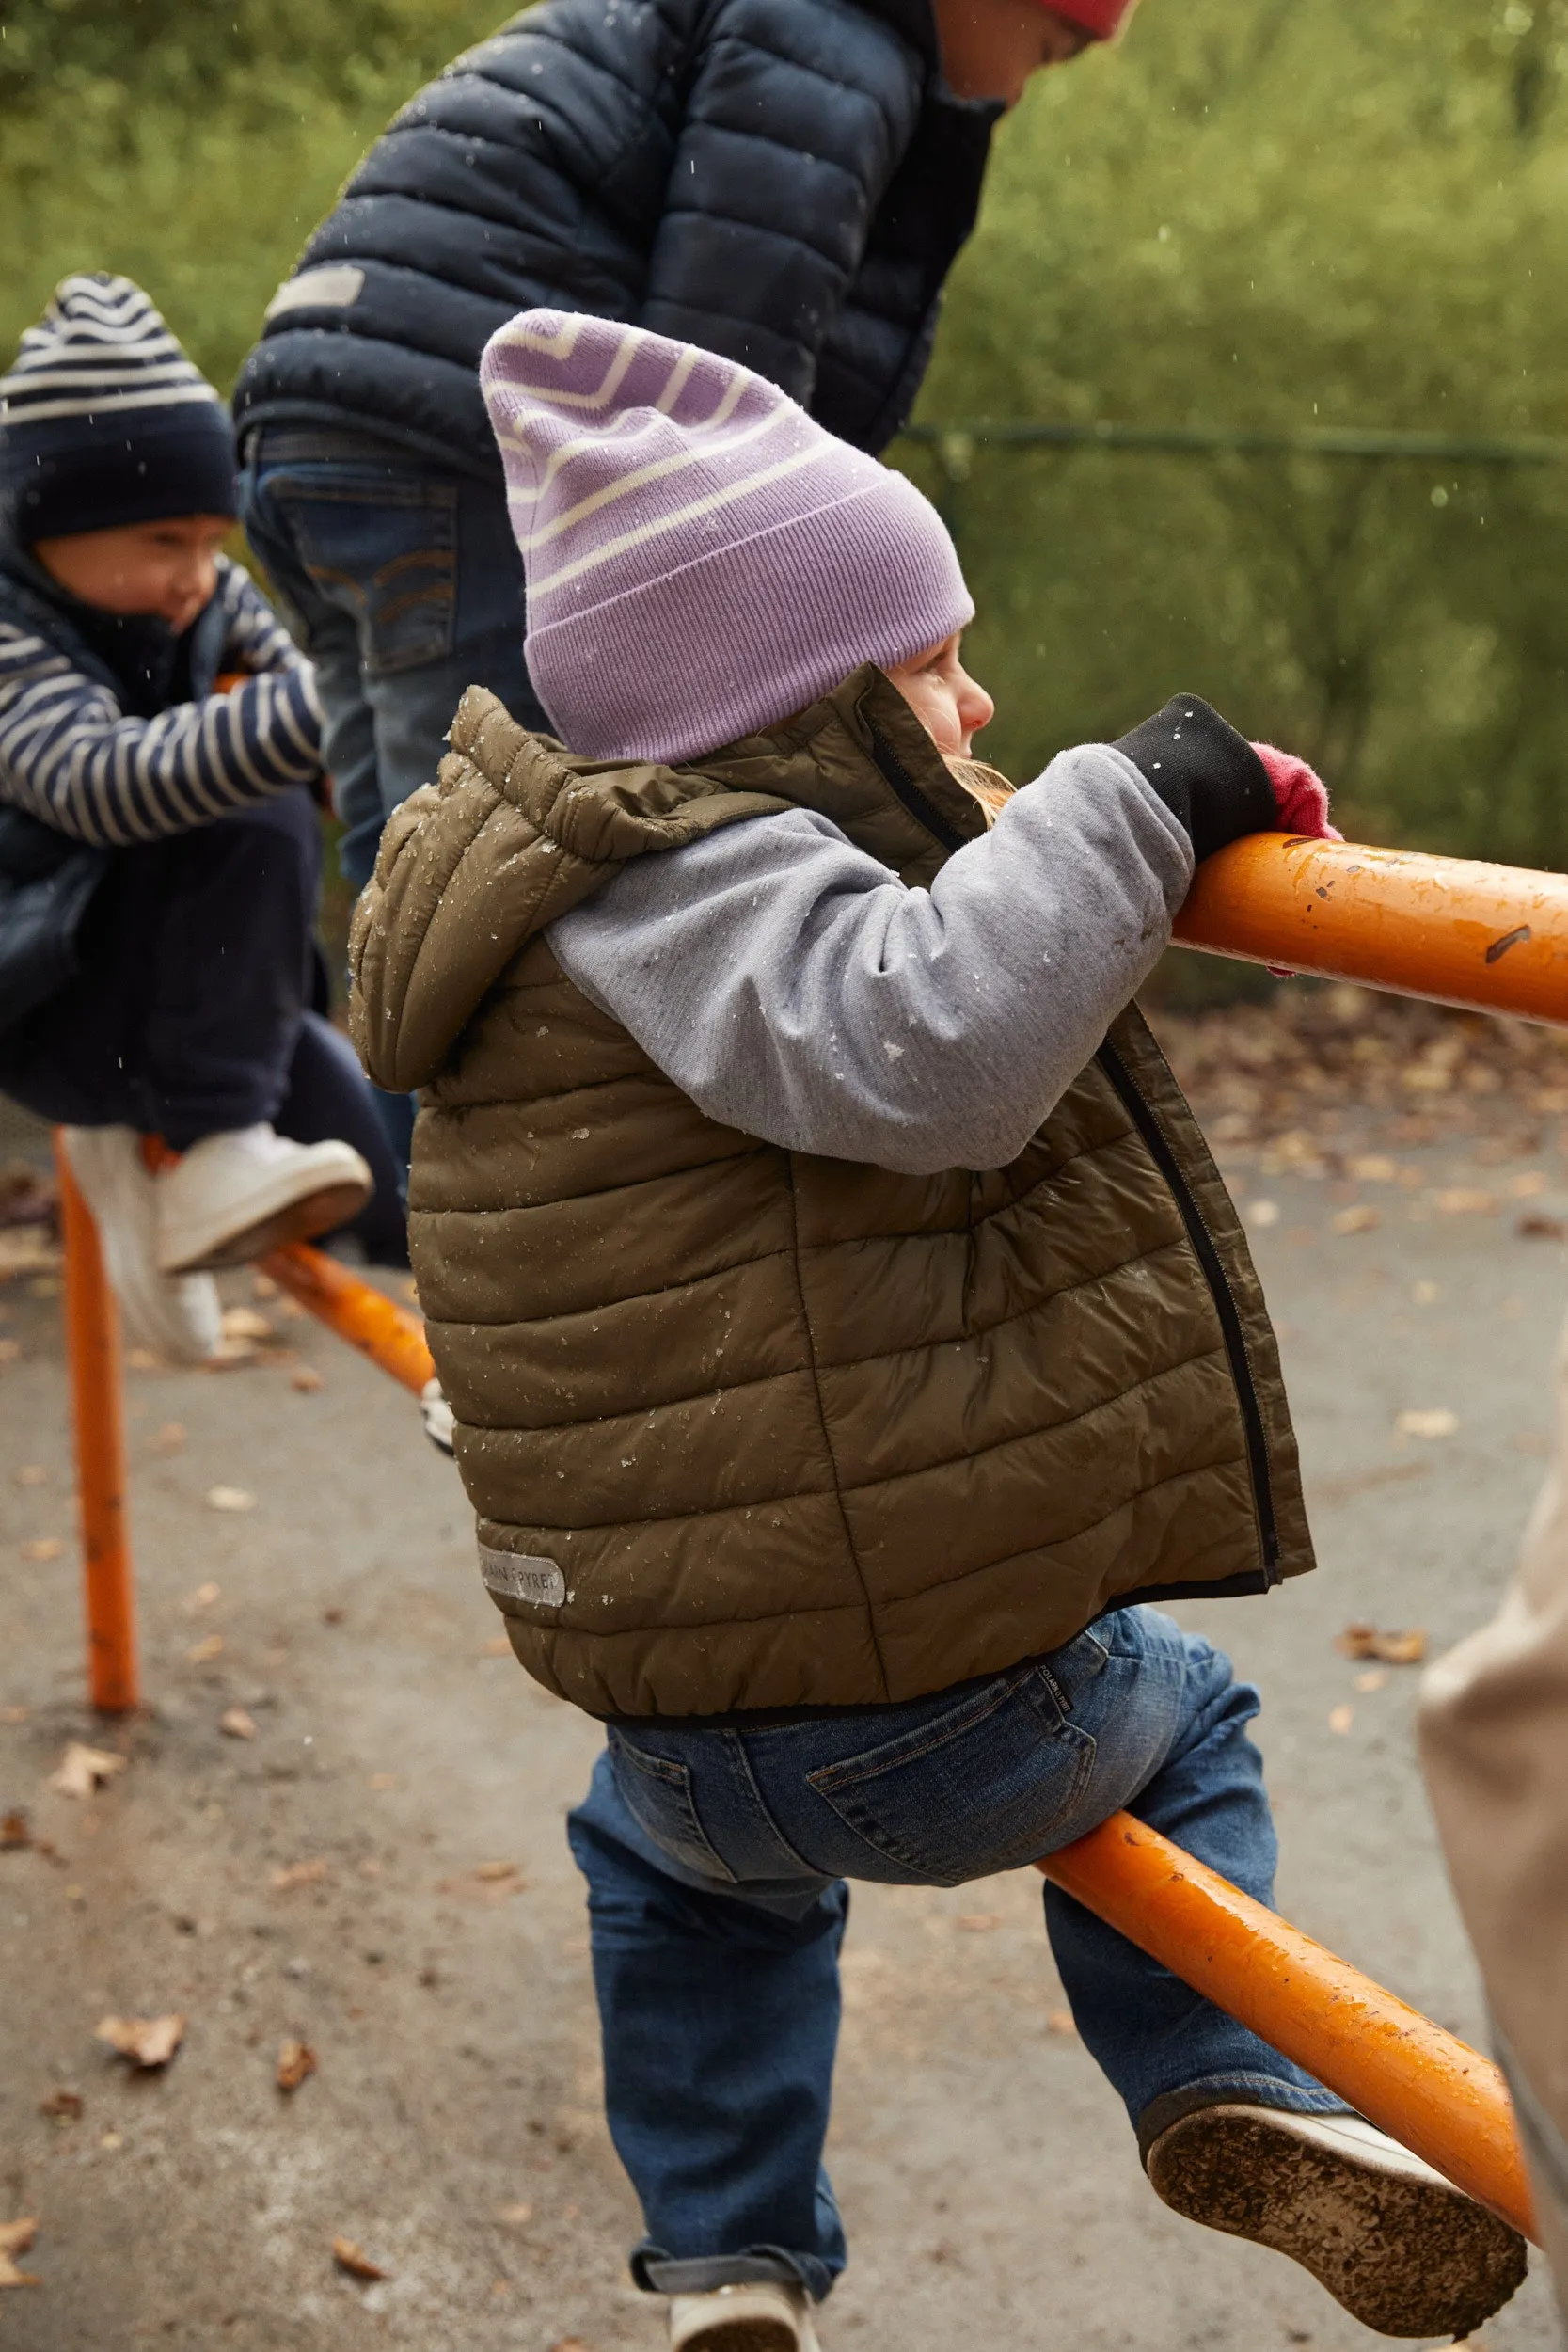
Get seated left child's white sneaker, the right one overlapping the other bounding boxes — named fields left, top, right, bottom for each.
left=152, top=1124, right=376, bottom=1275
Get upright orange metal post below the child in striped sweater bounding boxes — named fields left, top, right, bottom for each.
left=54, top=1136, right=141, bottom=1715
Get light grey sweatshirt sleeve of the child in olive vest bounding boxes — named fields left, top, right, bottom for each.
left=547, top=743, right=1192, bottom=1174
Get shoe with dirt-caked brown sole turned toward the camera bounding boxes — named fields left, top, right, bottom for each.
left=1145, top=2106, right=1526, bottom=2338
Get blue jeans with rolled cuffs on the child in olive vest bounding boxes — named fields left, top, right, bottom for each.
left=569, top=1609, right=1345, bottom=2298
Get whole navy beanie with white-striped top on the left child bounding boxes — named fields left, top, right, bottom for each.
left=0, top=271, right=237, bottom=546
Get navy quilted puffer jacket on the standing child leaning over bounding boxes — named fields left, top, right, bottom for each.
left=235, top=0, right=999, bottom=475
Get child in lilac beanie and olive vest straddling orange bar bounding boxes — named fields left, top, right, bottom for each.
left=353, top=310, right=1524, bottom=2352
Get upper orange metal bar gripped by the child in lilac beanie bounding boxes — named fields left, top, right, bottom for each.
left=1176, top=833, right=1568, bottom=1025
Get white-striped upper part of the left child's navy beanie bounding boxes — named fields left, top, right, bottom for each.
left=0, top=273, right=221, bottom=426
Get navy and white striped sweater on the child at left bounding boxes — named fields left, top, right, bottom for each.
left=0, top=555, right=322, bottom=850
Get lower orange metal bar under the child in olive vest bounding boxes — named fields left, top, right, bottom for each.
left=1037, top=1814, right=1538, bottom=2237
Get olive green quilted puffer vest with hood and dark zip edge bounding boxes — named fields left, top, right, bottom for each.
left=353, top=671, right=1312, bottom=1717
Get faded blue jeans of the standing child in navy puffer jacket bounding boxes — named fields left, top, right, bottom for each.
left=240, top=426, right=550, bottom=889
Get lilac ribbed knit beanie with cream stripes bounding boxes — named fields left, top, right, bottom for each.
left=480, top=310, right=974, bottom=760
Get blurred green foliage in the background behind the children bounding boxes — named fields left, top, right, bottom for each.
left=0, top=0, right=1568, bottom=864
